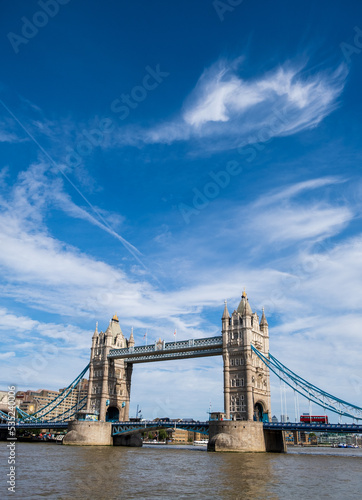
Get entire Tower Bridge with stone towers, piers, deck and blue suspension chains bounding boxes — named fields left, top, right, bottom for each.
left=0, top=291, right=362, bottom=452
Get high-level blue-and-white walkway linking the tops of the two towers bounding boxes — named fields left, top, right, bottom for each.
left=108, top=335, right=222, bottom=363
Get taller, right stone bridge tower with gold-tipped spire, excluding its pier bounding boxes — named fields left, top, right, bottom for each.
left=222, top=291, right=271, bottom=421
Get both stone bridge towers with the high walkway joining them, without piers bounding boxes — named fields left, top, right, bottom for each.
left=87, top=291, right=271, bottom=428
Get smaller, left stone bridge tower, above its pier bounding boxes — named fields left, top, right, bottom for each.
left=87, top=315, right=134, bottom=422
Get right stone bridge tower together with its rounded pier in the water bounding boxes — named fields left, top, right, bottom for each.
left=208, top=291, right=286, bottom=452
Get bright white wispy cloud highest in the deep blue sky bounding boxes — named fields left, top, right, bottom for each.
left=120, top=59, right=347, bottom=150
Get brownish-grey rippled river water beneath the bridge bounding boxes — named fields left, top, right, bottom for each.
left=0, top=442, right=362, bottom=500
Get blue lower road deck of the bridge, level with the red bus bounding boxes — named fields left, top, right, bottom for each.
left=0, top=420, right=362, bottom=436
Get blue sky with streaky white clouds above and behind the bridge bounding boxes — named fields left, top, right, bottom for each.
left=0, top=0, right=362, bottom=418
